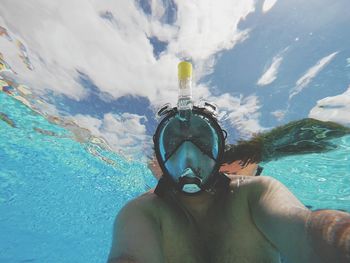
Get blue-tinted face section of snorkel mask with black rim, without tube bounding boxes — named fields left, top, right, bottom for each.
left=154, top=107, right=224, bottom=193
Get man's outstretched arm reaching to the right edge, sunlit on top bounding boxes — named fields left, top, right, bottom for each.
left=249, top=177, right=350, bottom=263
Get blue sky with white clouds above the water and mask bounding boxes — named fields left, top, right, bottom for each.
left=0, top=0, right=350, bottom=159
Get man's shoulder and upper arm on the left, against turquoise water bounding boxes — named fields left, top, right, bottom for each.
left=108, top=197, right=164, bottom=263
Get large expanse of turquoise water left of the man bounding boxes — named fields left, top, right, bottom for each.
left=0, top=93, right=155, bottom=262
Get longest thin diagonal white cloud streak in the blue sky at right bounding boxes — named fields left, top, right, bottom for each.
left=289, top=52, right=338, bottom=99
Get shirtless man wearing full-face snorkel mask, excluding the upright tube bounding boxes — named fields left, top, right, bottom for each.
left=108, top=63, right=350, bottom=263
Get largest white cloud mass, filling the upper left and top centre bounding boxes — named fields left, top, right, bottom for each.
left=0, top=0, right=254, bottom=104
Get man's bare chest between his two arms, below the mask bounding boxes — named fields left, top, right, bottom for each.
left=156, top=197, right=279, bottom=263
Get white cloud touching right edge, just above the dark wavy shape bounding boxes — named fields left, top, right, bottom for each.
left=309, top=86, right=350, bottom=126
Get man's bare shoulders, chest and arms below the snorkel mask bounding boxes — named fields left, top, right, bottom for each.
left=108, top=161, right=350, bottom=263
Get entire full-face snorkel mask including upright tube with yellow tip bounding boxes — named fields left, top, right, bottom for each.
left=153, top=62, right=226, bottom=194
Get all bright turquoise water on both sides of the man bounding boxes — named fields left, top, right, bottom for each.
left=0, top=92, right=350, bottom=263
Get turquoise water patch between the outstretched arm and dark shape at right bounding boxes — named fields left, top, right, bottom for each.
left=263, top=136, right=350, bottom=212
